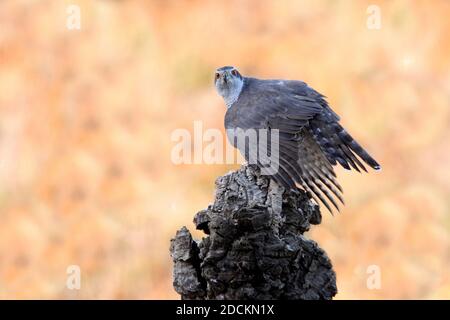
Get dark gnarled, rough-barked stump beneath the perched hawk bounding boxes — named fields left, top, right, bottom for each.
left=170, top=165, right=337, bottom=300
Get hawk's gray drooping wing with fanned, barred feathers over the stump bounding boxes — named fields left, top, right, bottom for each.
left=225, top=79, right=343, bottom=211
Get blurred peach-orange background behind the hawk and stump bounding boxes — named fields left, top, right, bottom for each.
left=0, top=0, right=450, bottom=299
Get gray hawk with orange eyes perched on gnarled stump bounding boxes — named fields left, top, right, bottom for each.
left=214, top=66, right=381, bottom=212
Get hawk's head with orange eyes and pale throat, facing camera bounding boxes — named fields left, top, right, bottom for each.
left=214, top=66, right=244, bottom=104
